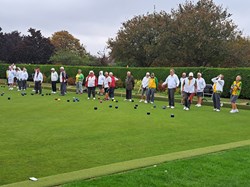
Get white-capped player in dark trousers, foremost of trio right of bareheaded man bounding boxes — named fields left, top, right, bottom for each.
left=182, top=72, right=197, bottom=110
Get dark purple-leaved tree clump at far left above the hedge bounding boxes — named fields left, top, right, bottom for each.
left=0, top=28, right=54, bottom=64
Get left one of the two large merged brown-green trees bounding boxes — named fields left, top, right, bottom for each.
left=108, top=12, right=171, bottom=67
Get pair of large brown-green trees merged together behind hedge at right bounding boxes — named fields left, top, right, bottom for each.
left=108, top=0, right=242, bottom=66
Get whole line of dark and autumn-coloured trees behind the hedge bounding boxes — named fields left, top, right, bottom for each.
left=0, top=0, right=250, bottom=67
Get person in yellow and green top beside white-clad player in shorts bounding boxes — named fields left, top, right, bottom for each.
left=145, top=73, right=158, bottom=104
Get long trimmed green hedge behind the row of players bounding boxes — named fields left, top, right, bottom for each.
left=0, top=64, right=250, bottom=99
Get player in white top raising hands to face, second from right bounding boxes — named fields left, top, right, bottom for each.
left=211, top=74, right=225, bottom=112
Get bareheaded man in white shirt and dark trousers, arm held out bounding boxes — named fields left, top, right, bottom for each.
left=162, top=69, right=180, bottom=108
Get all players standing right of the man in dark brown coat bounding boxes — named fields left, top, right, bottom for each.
left=137, top=69, right=242, bottom=113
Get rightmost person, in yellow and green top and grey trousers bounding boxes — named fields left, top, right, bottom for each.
left=230, top=75, right=242, bottom=113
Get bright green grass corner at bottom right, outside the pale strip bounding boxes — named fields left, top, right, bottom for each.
left=64, top=146, right=250, bottom=187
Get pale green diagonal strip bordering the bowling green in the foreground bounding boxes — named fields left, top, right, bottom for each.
left=2, top=140, right=250, bottom=187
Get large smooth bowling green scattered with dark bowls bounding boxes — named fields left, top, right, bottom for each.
left=0, top=88, right=250, bottom=185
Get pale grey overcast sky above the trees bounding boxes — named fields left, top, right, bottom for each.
left=0, top=0, right=250, bottom=55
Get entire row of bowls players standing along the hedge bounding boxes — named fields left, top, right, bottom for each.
left=6, top=64, right=242, bottom=113
